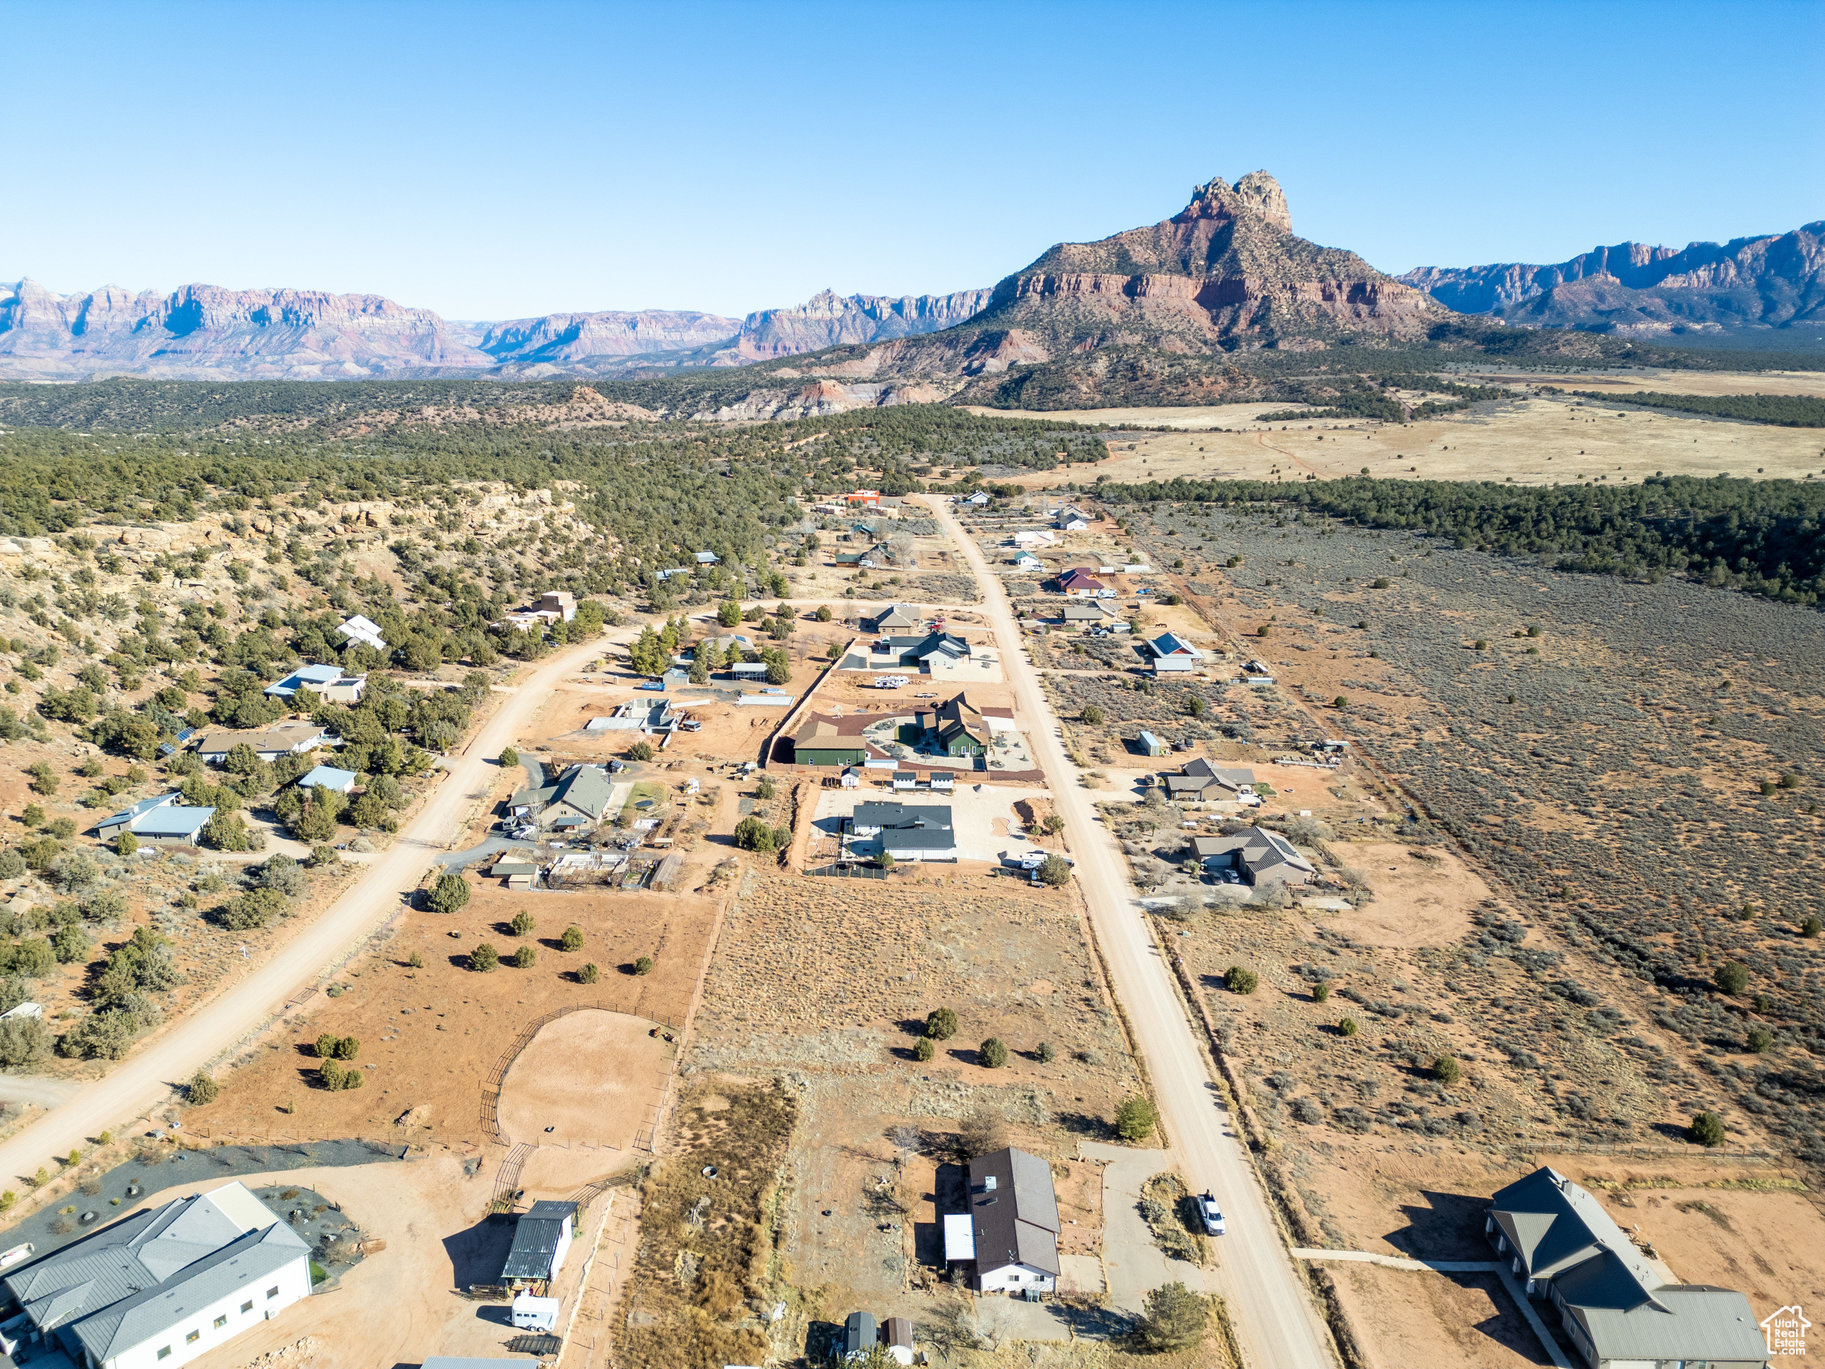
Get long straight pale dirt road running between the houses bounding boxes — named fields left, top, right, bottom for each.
left=929, top=496, right=1336, bottom=1369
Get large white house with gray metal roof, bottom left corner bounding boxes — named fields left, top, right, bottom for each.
left=0, top=1183, right=310, bottom=1369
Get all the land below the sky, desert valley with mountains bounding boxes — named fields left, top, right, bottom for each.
left=0, top=50, right=1825, bottom=1369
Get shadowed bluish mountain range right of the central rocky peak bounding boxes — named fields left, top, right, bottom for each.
left=1400, top=221, right=1825, bottom=338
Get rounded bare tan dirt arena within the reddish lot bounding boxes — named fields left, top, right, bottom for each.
left=498, top=1008, right=673, bottom=1150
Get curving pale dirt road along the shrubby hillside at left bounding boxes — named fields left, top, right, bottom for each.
left=0, top=639, right=606, bottom=1185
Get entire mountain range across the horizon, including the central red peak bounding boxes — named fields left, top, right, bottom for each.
left=0, top=182, right=1825, bottom=386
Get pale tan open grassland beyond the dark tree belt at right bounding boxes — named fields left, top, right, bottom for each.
left=978, top=386, right=1825, bottom=484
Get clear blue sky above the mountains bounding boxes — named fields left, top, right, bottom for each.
left=0, top=0, right=1825, bottom=319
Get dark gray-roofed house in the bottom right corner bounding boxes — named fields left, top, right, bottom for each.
left=1484, top=1168, right=1768, bottom=1369
